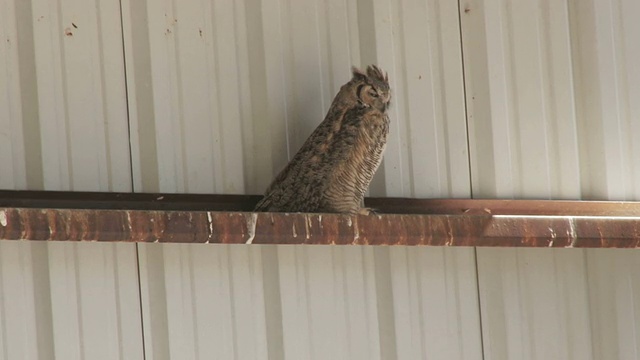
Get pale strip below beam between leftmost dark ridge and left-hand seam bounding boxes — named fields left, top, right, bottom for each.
left=48, top=244, right=142, bottom=359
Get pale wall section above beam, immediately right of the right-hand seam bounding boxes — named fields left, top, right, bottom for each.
left=461, top=0, right=581, bottom=198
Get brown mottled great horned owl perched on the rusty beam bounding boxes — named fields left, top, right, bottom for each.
left=254, top=65, right=391, bottom=214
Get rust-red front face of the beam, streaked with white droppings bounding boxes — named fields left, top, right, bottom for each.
left=0, top=208, right=640, bottom=248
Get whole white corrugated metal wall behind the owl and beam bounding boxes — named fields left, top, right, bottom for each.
left=0, top=0, right=640, bottom=359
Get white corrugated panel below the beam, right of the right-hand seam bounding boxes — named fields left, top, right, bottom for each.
left=477, top=248, right=640, bottom=359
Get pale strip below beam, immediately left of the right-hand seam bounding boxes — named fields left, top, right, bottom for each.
left=390, top=248, right=482, bottom=359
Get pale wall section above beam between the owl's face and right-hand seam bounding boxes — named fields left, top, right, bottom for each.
left=360, top=1, right=470, bottom=197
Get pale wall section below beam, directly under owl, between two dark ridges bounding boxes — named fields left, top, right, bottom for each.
left=278, top=246, right=381, bottom=359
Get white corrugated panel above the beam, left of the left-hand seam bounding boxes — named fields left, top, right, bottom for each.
left=0, top=0, right=131, bottom=191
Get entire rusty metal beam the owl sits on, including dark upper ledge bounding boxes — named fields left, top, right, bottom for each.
left=0, top=191, right=640, bottom=248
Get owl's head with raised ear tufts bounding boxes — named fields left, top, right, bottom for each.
left=351, top=65, right=391, bottom=113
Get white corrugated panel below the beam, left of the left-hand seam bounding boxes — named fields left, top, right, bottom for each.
left=0, top=241, right=143, bottom=360
